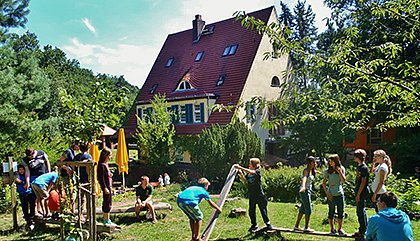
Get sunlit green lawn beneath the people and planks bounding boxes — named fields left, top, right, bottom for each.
left=0, top=185, right=420, bottom=241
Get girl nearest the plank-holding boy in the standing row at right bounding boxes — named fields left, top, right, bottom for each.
left=294, top=156, right=317, bottom=232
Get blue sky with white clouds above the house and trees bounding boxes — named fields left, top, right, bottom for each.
left=19, top=0, right=330, bottom=87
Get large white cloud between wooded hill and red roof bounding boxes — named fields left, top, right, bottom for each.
left=63, top=38, right=159, bottom=87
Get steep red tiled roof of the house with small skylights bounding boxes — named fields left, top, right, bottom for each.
left=125, top=7, right=274, bottom=137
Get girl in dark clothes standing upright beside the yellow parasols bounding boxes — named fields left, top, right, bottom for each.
left=97, top=147, right=115, bottom=225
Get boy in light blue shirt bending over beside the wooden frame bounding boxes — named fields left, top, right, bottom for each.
left=31, top=166, right=58, bottom=218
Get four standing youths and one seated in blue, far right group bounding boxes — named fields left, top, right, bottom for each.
left=294, top=149, right=413, bottom=240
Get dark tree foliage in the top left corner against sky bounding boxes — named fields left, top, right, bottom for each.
left=0, top=0, right=29, bottom=38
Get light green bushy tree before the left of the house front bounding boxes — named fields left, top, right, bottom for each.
left=136, top=95, right=175, bottom=165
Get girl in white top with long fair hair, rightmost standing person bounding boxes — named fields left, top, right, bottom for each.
left=371, top=150, right=392, bottom=212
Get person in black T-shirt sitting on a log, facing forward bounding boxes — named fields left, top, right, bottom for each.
left=135, top=176, right=157, bottom=224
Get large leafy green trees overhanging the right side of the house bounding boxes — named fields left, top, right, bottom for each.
left=237, top=0, right=420, bottom=129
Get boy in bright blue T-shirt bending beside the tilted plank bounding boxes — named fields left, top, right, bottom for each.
left=177, top=177, right=222, bottom=241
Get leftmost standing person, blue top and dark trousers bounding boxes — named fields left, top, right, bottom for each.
left=15, top=165, right=36, bottom=229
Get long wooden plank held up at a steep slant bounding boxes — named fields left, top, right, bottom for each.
left=201, top=166, right=238, bottom=241
